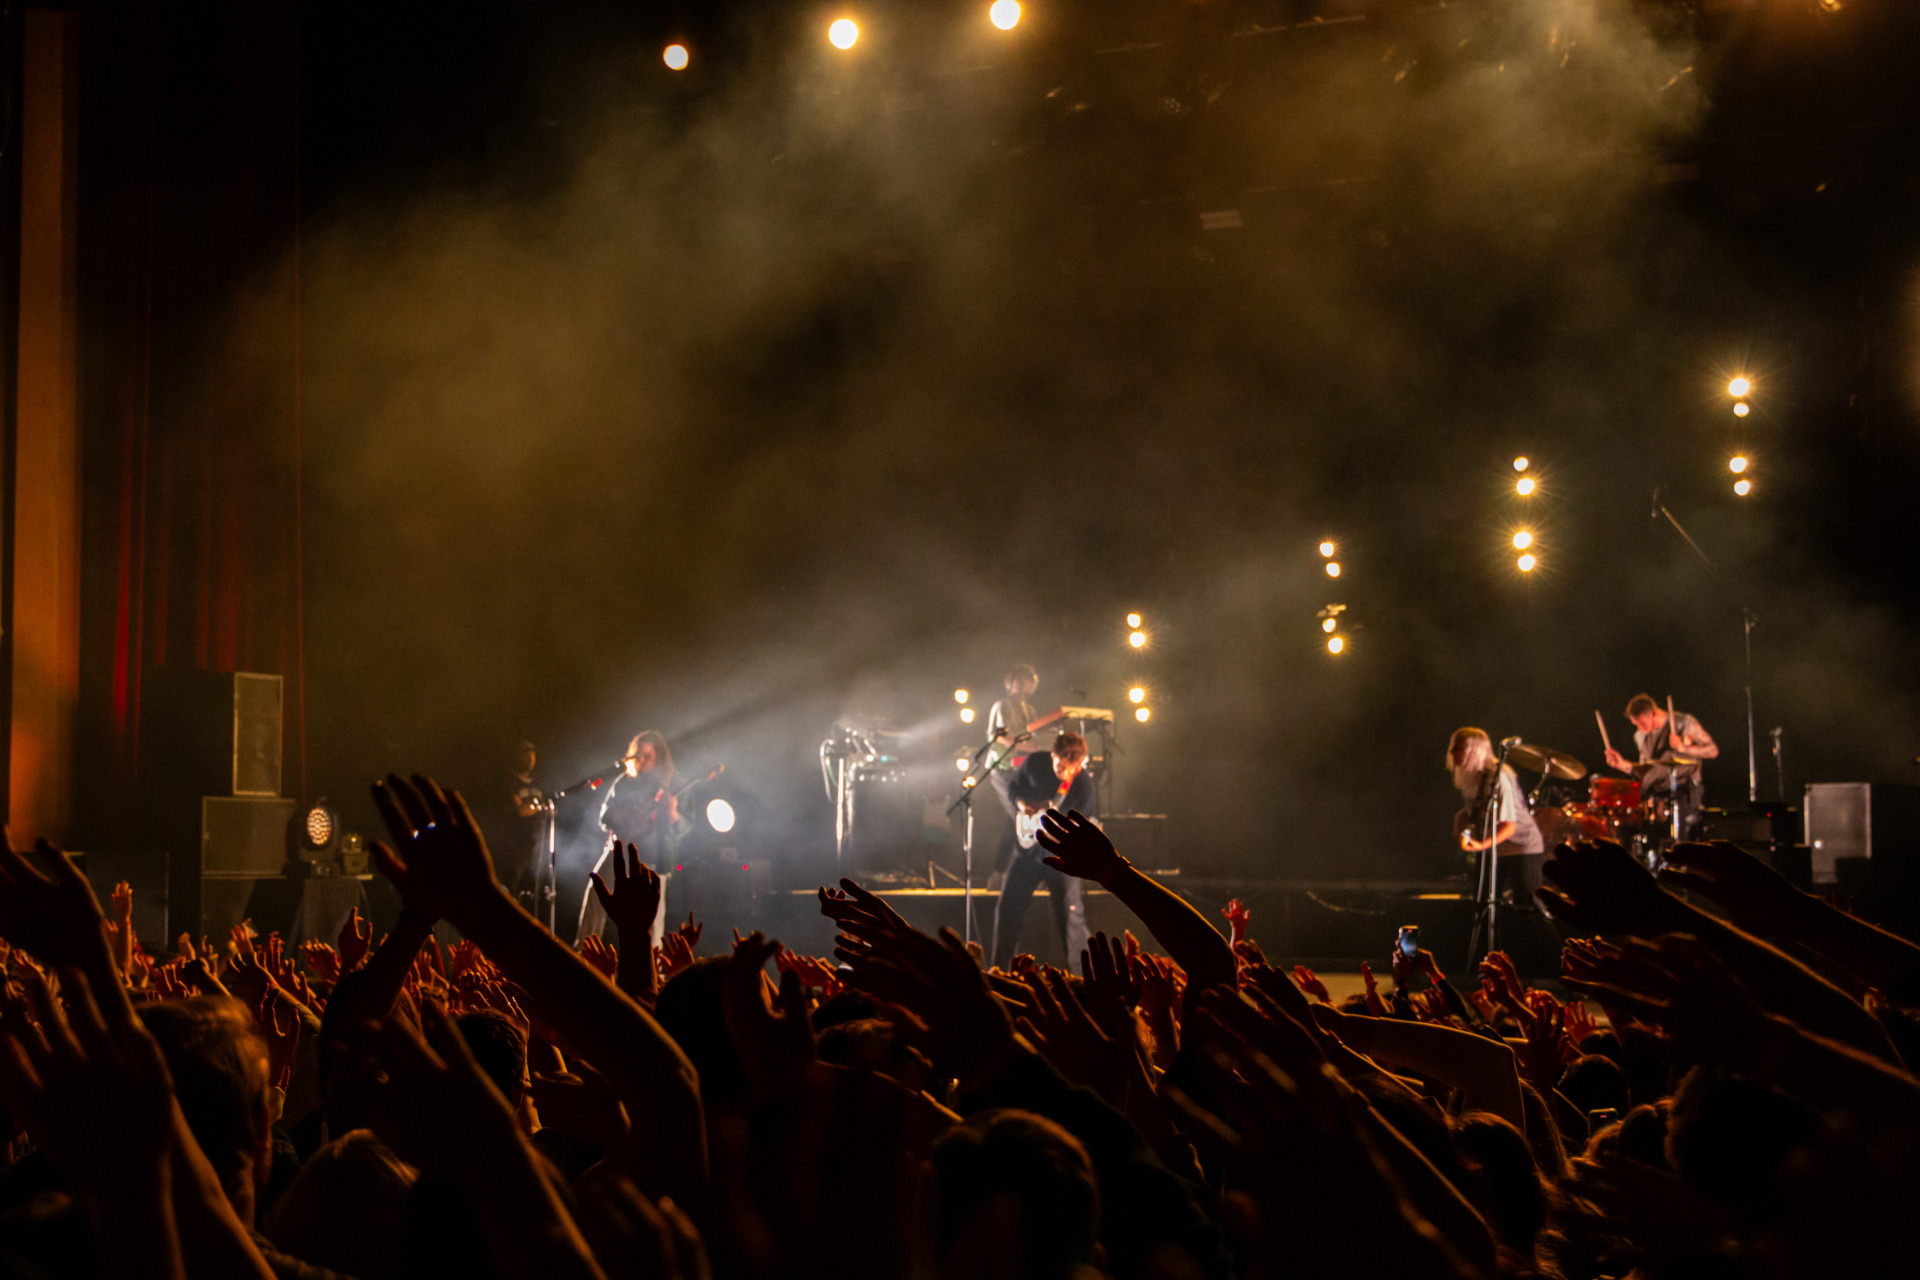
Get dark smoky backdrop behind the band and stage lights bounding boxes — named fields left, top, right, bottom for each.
left=56, top=0, right=1920, bottom=890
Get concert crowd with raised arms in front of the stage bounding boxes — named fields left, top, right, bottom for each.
left=0, top=777, right=1920, bottom=1280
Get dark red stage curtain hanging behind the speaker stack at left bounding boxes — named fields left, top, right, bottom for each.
left=77, top=4, right=305, bottom=844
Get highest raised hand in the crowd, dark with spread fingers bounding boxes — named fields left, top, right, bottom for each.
left=372, top=773, right=509, bottom=925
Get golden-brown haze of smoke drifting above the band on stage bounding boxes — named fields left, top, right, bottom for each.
left=278, top=0, right=1912, bottom=865
